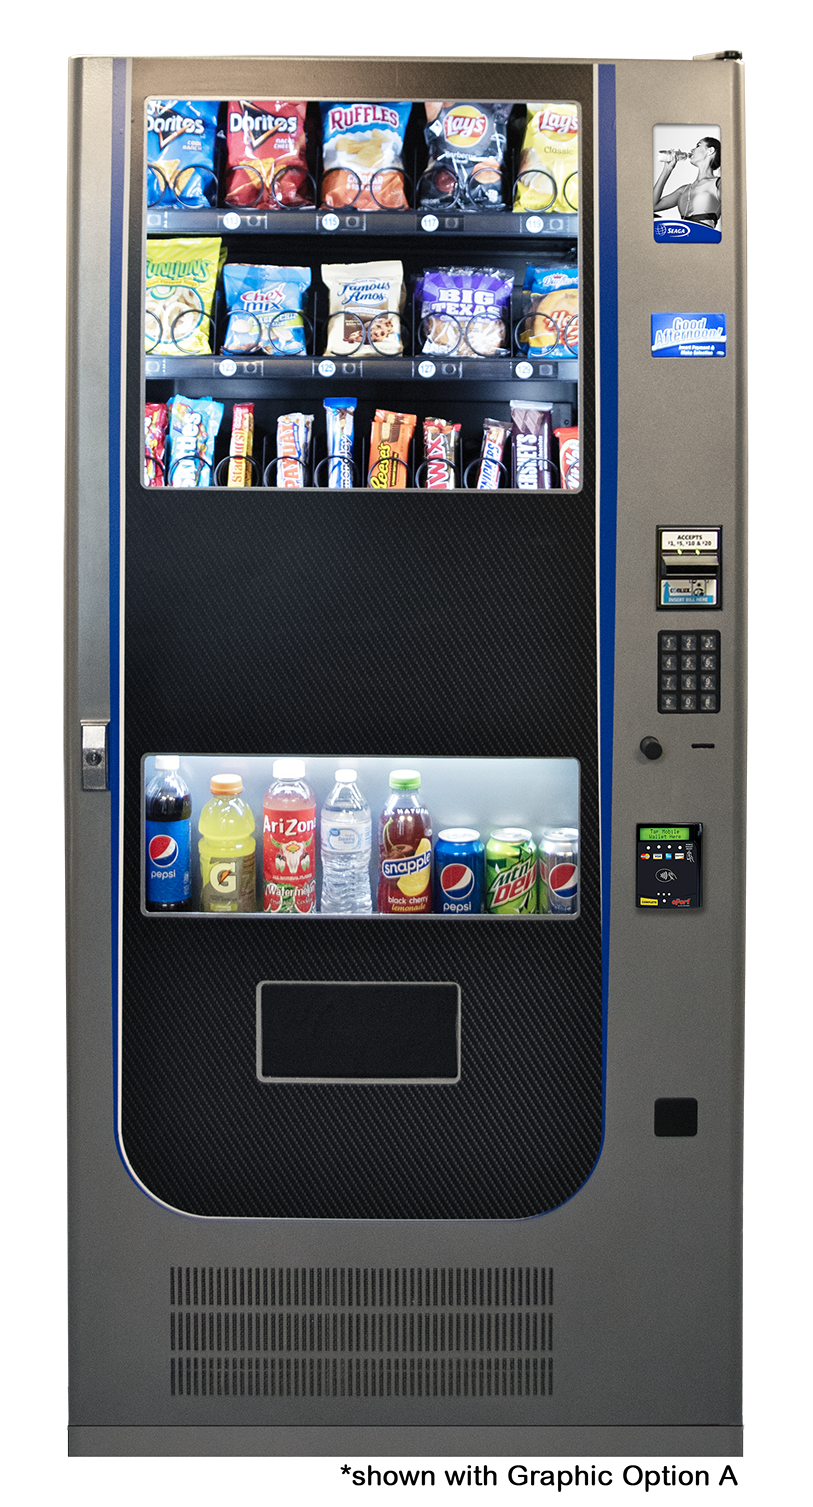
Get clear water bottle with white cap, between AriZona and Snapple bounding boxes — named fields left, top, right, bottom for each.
left=320, top=769, right=373, bottom=916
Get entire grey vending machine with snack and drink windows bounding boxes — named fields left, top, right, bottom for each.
left=66, top=53, right=747, bottom=1457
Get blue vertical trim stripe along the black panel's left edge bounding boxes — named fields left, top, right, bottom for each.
left=107, top=57, right=127, bottom=1144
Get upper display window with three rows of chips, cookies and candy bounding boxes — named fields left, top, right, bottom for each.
left=143, top=99, right=584, bottom=491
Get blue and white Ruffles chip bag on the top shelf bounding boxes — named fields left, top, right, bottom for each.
left=321, top=104, right=412, bottom=211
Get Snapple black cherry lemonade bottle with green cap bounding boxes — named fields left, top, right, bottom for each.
left=379, top=769, right=431, bottom=916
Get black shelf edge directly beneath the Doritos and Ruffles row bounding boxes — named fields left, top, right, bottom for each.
left=146, top=208, right=579, bottom=241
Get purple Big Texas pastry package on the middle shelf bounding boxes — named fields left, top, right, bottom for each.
left=415, top=267, right=514, bottom=356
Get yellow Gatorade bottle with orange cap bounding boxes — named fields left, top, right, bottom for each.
left=198, top=775, right=256, bottom=912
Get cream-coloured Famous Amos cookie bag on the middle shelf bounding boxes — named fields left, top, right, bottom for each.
left=321, top=262, right=406, bottom=357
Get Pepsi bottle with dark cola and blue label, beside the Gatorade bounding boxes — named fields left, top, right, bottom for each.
left=145, top=754, right=192, bottom=910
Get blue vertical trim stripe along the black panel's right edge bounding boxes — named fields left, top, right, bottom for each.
left=597, top=63, right=618, bottom=1048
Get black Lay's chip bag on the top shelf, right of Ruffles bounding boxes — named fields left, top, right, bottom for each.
left=418, top=99, right=511, bottom=212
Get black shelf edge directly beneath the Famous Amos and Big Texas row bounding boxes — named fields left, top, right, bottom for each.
left=145, top=354, right=579, bottom=379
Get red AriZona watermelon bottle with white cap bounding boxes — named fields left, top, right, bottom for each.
left=262, top=758, right=317, bottom=915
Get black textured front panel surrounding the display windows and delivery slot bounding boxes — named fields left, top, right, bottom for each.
left=122, top=68, right=602, bottom=1219
